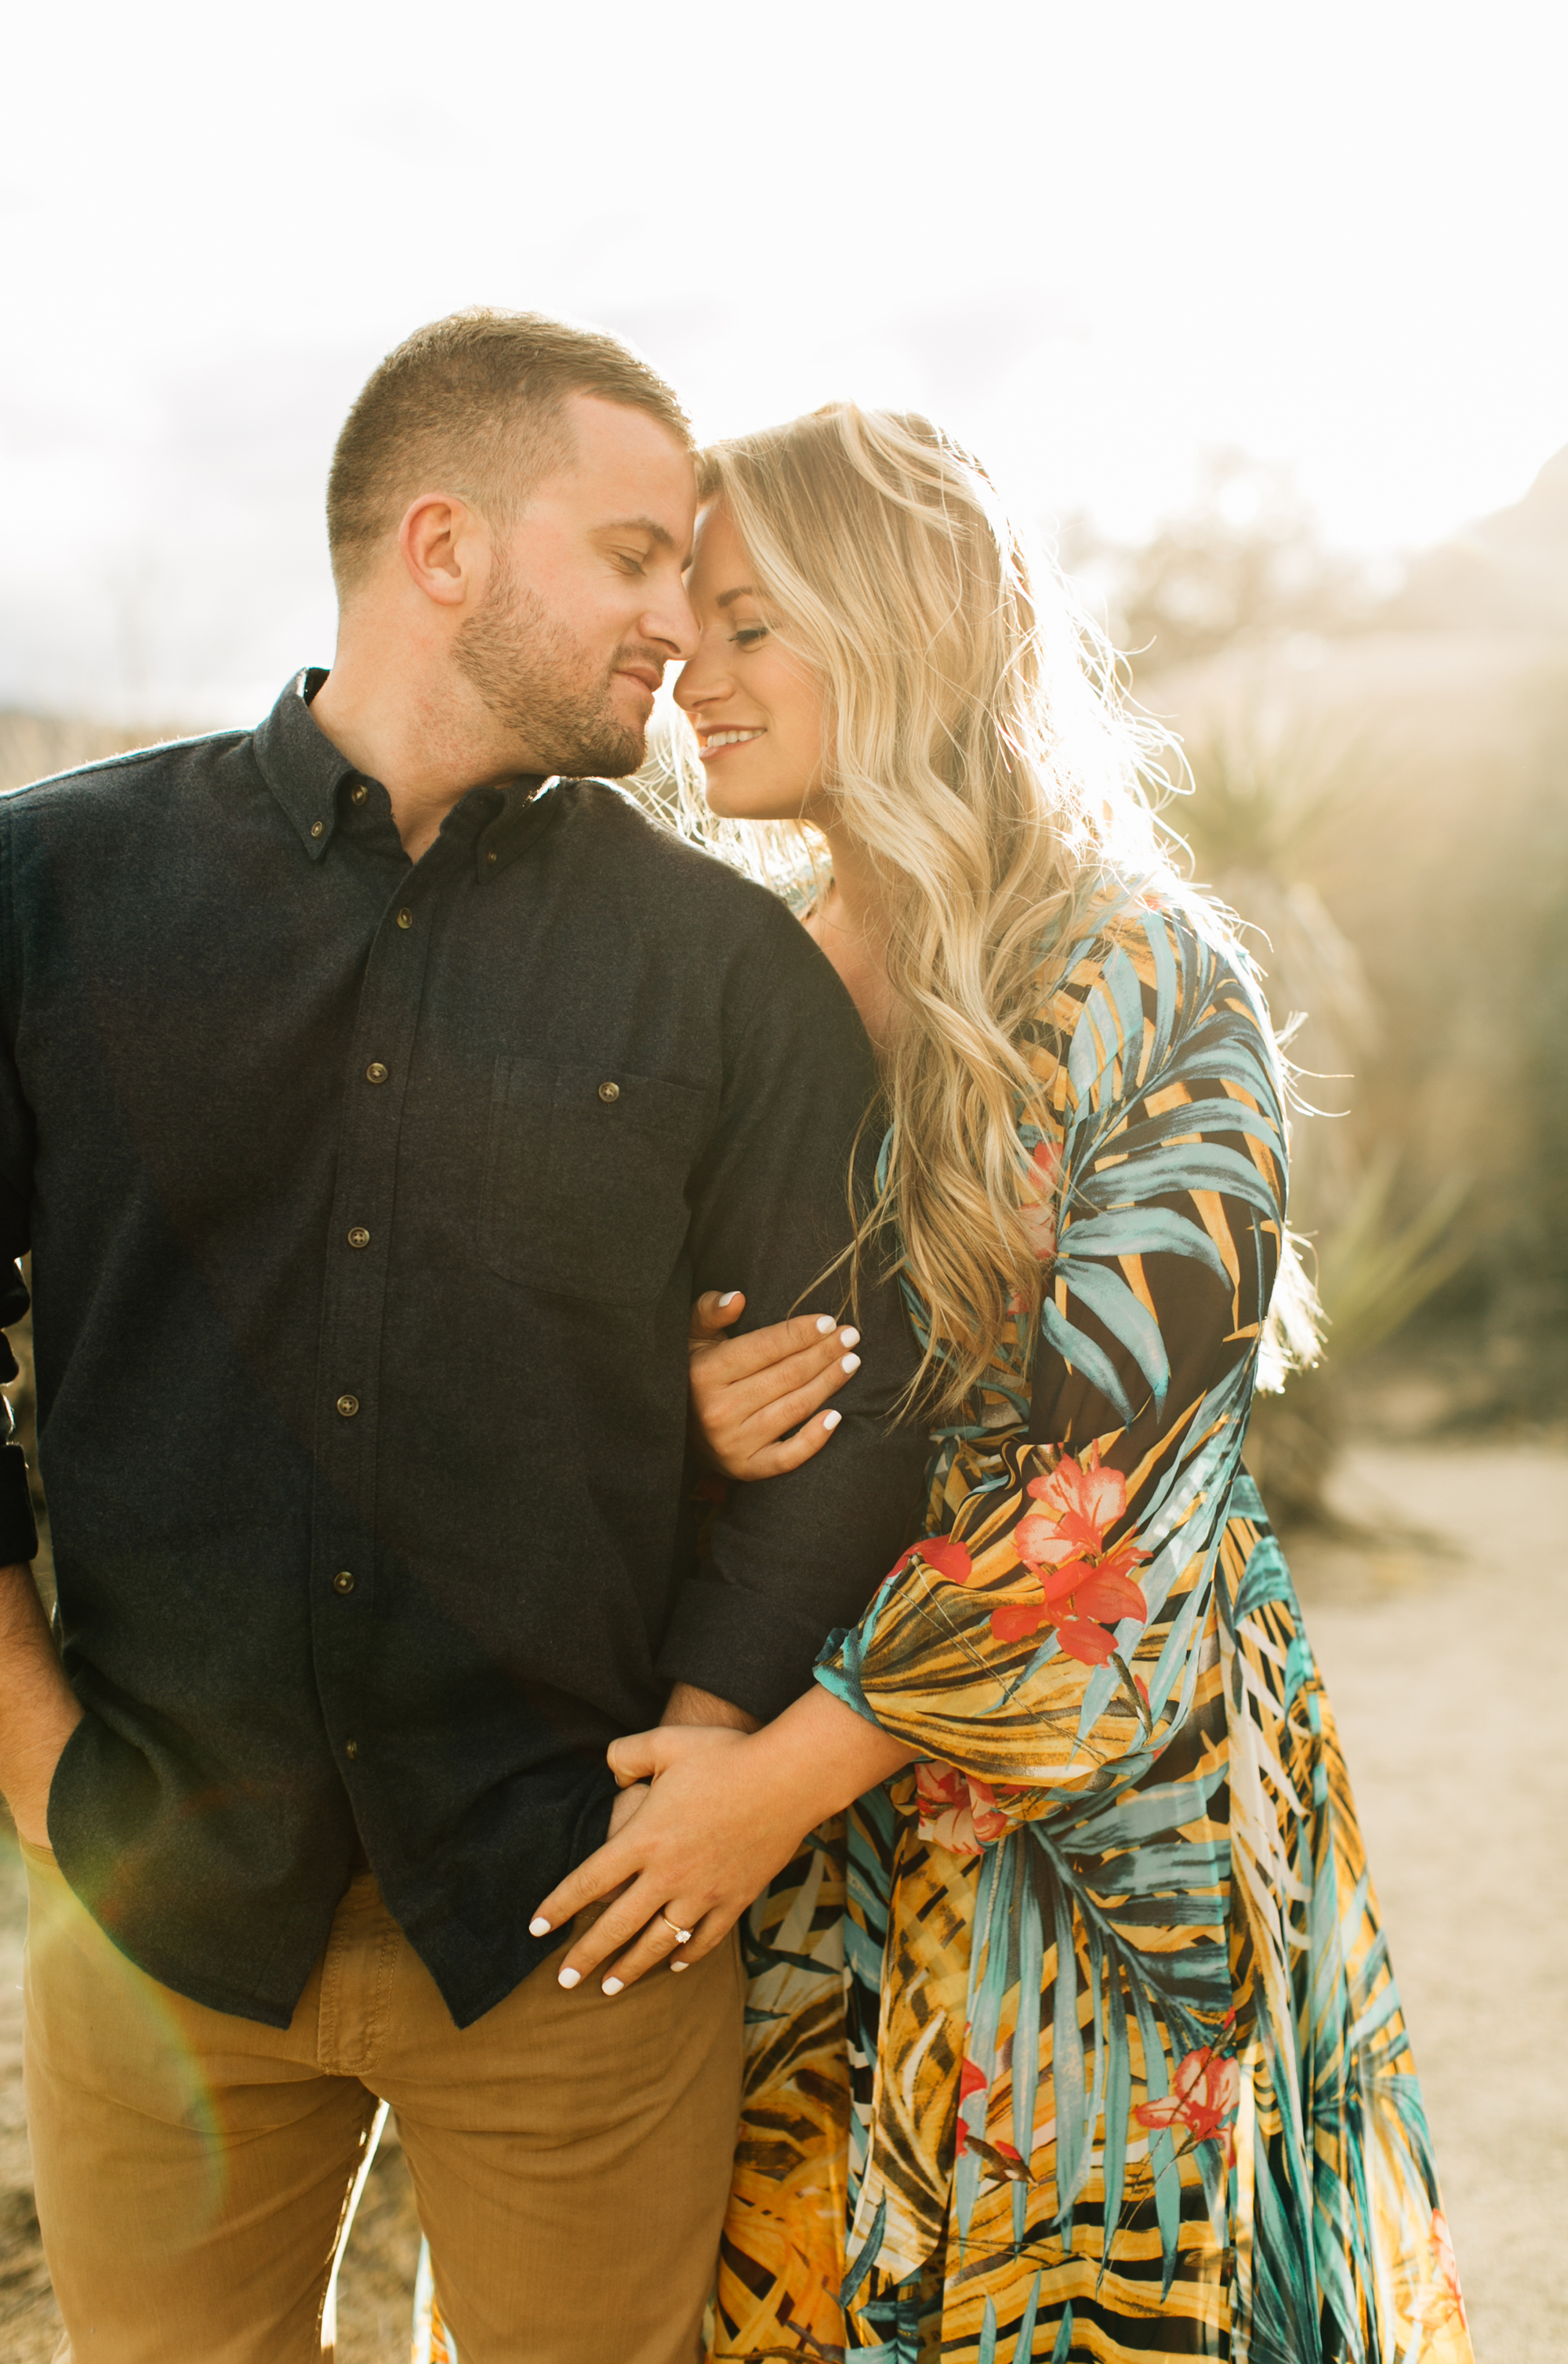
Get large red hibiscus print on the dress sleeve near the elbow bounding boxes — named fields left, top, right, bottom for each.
left=991, top=1444, right=1149, bottom=1667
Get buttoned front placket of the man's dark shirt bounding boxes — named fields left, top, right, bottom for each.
left=310, top=848, right=452, bottom=1789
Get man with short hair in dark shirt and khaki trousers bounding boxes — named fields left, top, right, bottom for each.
left=0, top=312, right=920, bottom=2364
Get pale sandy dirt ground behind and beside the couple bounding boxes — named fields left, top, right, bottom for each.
left=0, top=1444, right=1568, bottom=2364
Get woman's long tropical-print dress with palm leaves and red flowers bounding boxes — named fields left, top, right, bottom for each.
left=710, top=906, right=1471, bottom=2364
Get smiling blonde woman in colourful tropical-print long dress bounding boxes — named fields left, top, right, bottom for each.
left=539, top=407, right=1471, bottom=2364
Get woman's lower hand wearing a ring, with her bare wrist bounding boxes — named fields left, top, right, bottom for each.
left=530, top=1683, right=917, bottom=1995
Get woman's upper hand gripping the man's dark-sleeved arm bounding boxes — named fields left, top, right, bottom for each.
left=691, top=1288, right=861, bottom=1477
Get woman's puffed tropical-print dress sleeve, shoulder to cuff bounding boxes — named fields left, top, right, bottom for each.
left=816, top=910, right=1284, bottom=1806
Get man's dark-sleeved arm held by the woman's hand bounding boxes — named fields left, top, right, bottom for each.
left=660, top=906, right=927, bottom=1726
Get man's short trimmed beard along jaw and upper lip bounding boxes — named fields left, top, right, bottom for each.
left=452, top=553, right=662, bottom=780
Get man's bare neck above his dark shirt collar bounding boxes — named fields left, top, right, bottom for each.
left=310, top=650, right=518, bottom=862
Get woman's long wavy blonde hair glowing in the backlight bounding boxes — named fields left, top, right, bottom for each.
left=670, top=402, right=1305, bottom=1411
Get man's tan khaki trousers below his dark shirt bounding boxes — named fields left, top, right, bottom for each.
left=24, top=1849, right=742, bottom=2364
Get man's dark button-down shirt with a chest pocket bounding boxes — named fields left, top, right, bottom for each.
left=0, top=676, right=920, bottom=2026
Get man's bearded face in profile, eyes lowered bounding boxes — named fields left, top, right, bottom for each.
left=452, top=395, right=698, bottom=778
